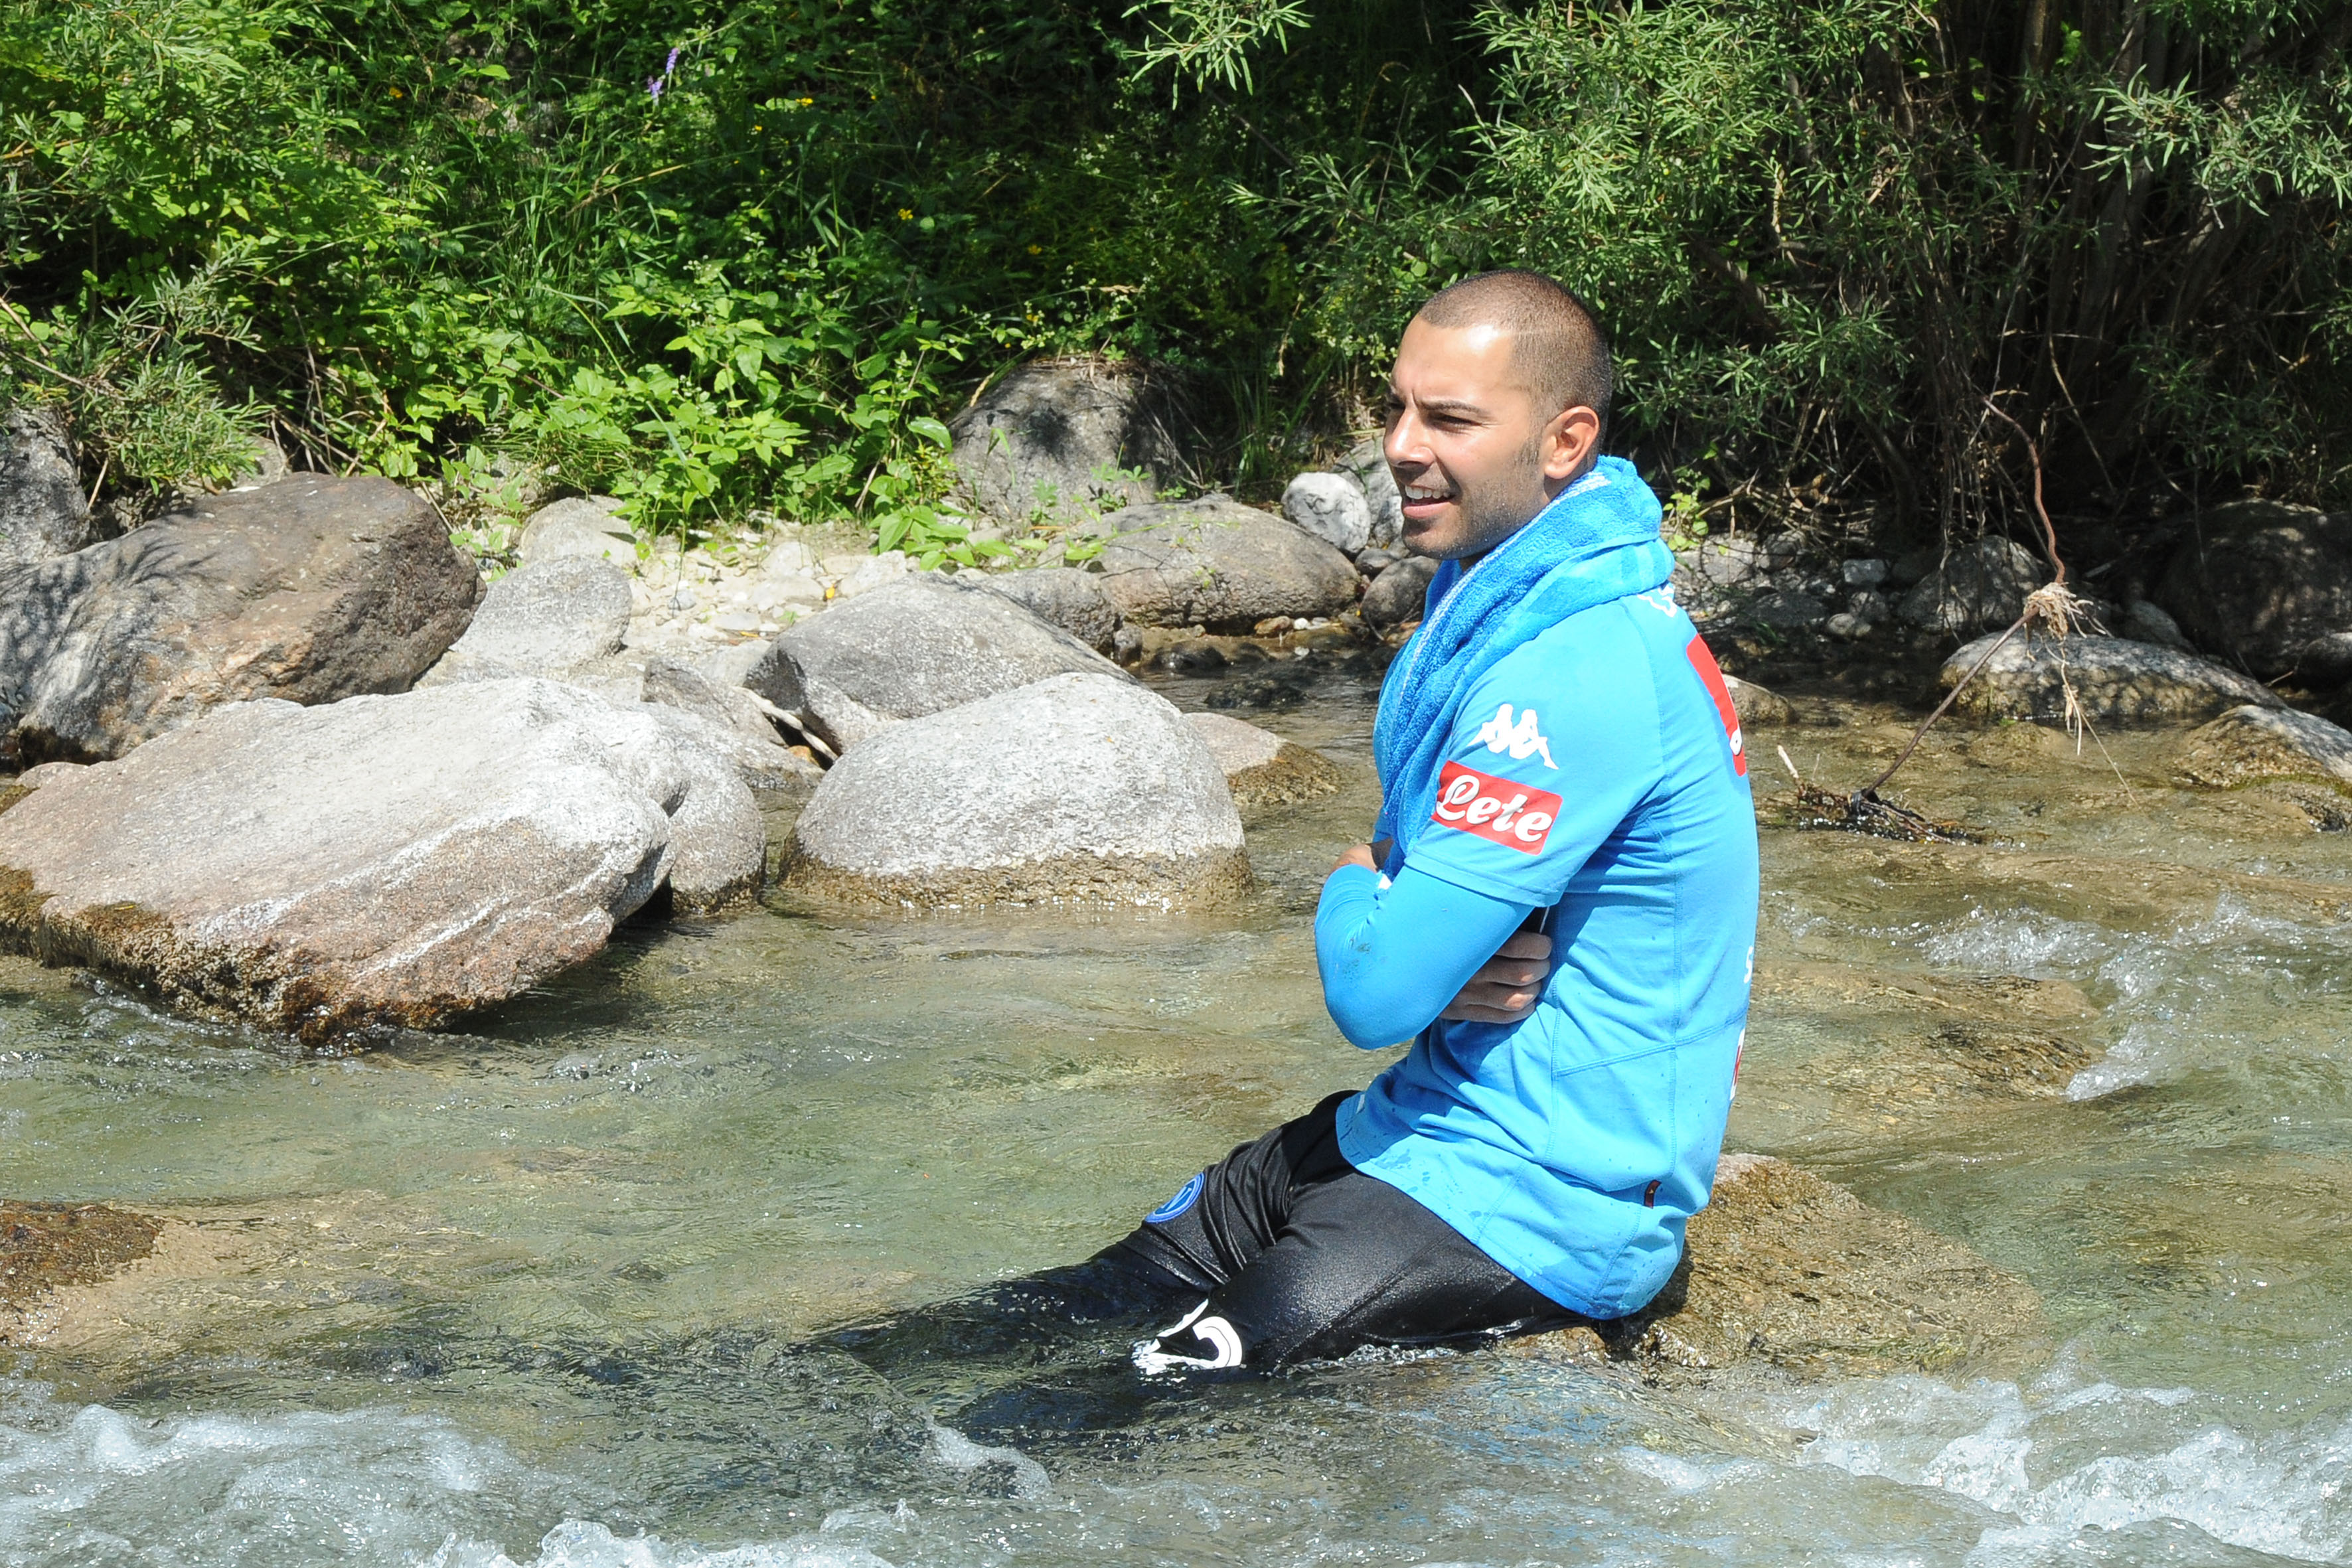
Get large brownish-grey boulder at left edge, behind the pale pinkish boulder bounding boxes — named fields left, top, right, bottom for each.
left=0, top=475, right=482, bottom=766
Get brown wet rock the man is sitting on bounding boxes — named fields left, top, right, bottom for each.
left=1517, top=1154, right=2049, bottom=1377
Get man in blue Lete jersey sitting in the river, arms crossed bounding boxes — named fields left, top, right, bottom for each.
left=1089, top=273, right=1757, bottom=1371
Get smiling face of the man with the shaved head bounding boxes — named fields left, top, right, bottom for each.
left=1385, top=317, right=1599, bottom=560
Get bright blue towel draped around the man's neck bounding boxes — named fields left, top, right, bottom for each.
left=1372, top=459, right=1675, bottom=872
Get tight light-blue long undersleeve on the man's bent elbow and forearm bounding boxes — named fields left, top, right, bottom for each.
left=1315, top=865, right=1533, bottom=1051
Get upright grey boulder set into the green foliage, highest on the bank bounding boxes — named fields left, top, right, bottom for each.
left=948, top=360, right=1186, bottom=524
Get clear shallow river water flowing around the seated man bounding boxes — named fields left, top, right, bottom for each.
left=0, top=672, right=2352, bottom=1568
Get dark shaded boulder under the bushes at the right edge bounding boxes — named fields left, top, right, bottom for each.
left=2154, top=501, right=2352, bottom=679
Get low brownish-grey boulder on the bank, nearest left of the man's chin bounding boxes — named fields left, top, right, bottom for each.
left=1096, top=496, right=1357, bottom=633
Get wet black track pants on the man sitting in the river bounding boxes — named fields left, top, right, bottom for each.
left=1096, top=1093, right=1583, bottom=1368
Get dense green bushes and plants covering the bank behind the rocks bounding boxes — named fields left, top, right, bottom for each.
left=0, top=0, right=2352, bottom=562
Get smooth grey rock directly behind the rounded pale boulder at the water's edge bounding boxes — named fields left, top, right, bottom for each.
left=744, top=574, right=1127, bottom=752
